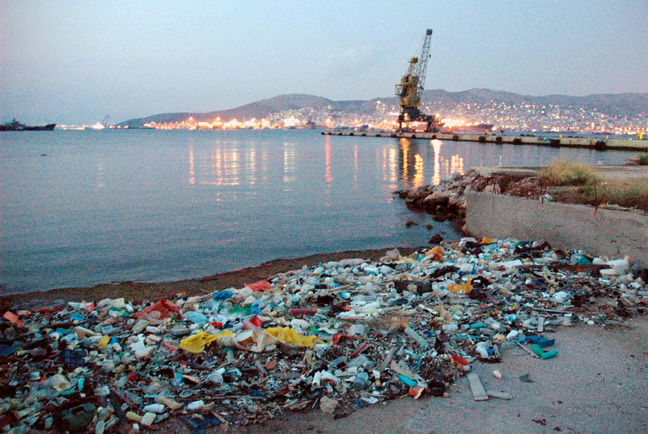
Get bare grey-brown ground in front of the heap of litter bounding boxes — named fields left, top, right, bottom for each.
left=160, top=317, right=648, bottom=434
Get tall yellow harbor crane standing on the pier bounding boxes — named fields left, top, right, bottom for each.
left=396, top=29, right=439, bottom=132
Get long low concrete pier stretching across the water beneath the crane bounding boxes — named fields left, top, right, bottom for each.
left=322, top=130, right=648, bottom=152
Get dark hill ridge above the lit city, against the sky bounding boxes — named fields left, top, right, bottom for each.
left=118, top=89, right=648, bottom=128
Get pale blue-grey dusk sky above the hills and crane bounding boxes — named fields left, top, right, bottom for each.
left=0, top=0, right=648, bottom=124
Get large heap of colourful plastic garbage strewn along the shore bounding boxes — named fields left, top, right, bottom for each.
left=0, top=238, right=648, bottom=433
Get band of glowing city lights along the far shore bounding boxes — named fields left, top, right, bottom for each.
left=128, top=100, right=648, bottom=135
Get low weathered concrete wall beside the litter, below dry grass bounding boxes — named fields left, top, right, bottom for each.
left=465, top=191, right=648, bottom=267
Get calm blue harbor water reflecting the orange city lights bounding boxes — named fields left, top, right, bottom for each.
left=0, top=130, right=628, bottom=292
